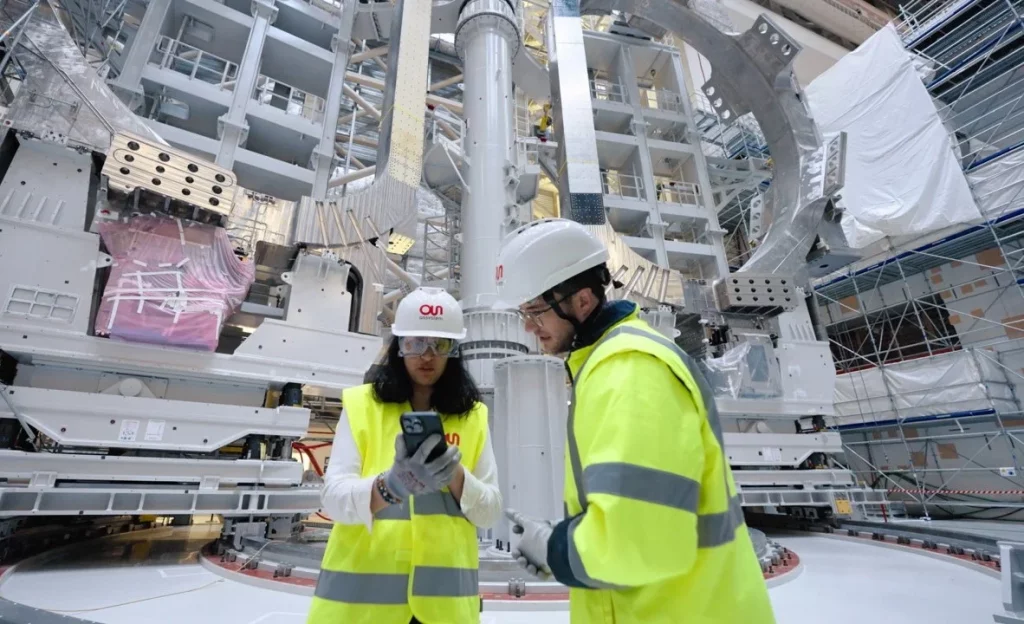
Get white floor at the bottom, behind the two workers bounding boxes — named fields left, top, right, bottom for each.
left=0, top=528, right=1000, bottom=624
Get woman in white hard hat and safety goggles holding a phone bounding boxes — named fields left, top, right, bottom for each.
left=308, top=288, right=502, bottom=624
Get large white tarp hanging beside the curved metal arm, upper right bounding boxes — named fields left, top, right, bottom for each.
left=806, top=24, right=981, bottom=248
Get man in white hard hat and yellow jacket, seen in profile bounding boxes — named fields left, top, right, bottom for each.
left=496, top=219, right=774, bottom=624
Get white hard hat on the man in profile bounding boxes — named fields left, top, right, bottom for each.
left=495, top=219, right=608, bottom=309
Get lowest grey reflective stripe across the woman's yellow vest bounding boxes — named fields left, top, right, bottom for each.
left=314, top=566, right=479, bottom=605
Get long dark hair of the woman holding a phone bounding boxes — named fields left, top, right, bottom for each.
left=371, top=337, right=480, bottom=416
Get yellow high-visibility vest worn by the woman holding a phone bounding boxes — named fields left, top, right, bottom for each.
left=307, top=384, right=487, bottom=624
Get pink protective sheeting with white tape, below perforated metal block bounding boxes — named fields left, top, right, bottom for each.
left=96, top=215, right=256, bottom=351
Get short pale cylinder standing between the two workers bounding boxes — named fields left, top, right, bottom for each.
left=490, top=356, right=569, bottom=543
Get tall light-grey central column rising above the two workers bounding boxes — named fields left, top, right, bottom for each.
left=455, top=0, right=520, bottom=309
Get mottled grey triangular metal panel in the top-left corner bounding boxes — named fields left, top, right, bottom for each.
left=3, top=2, right=164, bottom=152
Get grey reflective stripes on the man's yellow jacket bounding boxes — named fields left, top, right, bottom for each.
left=566, top=327, right=743, bottom=549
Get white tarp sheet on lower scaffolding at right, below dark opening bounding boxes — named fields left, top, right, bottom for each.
left=836, top=349, right=1015, bottom=425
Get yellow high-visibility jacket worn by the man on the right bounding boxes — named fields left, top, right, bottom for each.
left=564, top=310, right=775, bottom=624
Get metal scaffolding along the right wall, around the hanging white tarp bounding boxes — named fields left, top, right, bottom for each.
left=814, top=0, right=1024, bottom=517
